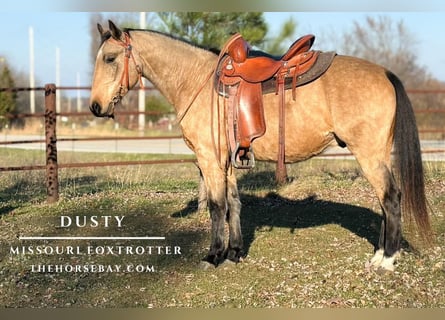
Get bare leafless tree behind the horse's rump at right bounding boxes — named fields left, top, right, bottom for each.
left=341, top=16, right=445, bottom=135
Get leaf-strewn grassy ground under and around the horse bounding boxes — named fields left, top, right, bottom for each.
left=0, top=148, right=445, bottom=308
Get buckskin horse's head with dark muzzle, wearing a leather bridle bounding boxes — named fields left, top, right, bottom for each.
left=90, top=21, right=142, bottom=118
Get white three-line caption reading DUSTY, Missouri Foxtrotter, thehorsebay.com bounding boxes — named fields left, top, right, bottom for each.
left=9, top=215, right=182, bottom=273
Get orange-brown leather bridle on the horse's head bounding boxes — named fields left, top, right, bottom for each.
left=109, top=32, right=144, bottom=112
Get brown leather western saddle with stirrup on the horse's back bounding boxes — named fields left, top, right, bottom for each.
left=215, top=34, right=332, bottom=178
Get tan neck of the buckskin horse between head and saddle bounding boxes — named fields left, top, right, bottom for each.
left=132, top=31, right=216, bottom=112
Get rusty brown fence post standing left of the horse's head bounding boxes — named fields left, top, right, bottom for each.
left=45, top=84, right=59, bottom=203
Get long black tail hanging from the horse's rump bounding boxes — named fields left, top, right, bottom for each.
left=387, top=71, right=433, bottom=243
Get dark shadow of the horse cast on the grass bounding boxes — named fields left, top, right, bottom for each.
left=172, top=172, right=410, bottom=254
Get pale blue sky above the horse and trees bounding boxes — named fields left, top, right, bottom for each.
left=0, top=11, right=445, bottom=94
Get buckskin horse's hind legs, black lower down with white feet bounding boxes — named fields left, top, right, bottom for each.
left=356, top=154, right=401, bottom=271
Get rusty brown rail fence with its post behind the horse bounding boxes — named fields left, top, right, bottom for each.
left=0, top=84, right=445, bottom=203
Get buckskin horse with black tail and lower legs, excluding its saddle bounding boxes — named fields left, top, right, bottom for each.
left=90, top=21, right=431, bottom=271
